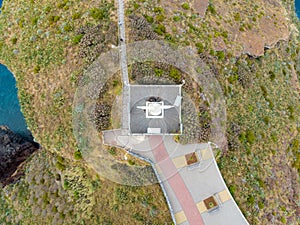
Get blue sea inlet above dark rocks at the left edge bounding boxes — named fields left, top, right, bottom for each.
left=0, top=64, right=33, bottom=140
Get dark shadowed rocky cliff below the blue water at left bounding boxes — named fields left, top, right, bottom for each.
left=0, top=126, right=38, bottom=186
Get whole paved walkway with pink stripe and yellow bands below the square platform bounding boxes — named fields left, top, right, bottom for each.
left=103, top=130, right=249, bottom=225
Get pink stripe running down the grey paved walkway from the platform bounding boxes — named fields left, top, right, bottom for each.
left=149, top=136, right=204, bottom=225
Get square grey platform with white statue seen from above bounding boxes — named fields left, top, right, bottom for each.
left=129, top=85, right=182, bottom=135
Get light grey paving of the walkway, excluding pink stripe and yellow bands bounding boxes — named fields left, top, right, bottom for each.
left=104, top=130, right=248, bottom=225
